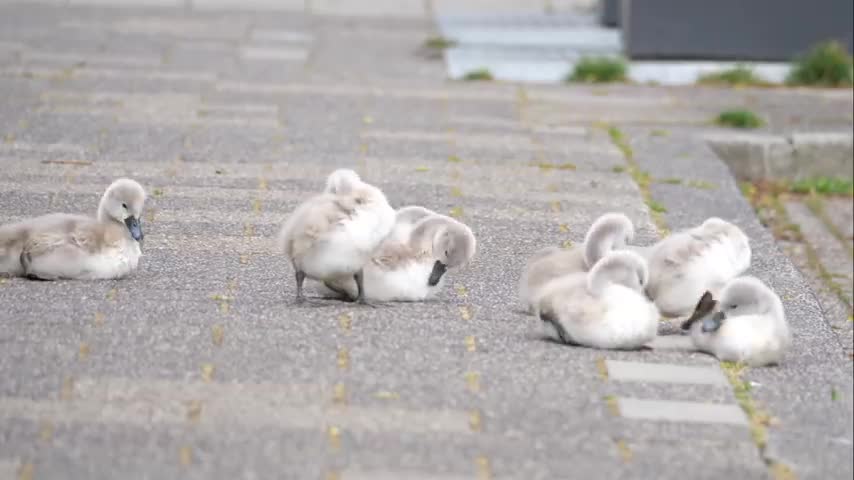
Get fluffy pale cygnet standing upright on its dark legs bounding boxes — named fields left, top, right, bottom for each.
left=279, top=169, right=395, bottom=303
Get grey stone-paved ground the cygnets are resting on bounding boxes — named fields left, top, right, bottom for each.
left=0, top=0, right=854, bottom=480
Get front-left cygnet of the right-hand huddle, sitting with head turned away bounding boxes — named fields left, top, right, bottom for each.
left=537, top=250, right=659, bottom=349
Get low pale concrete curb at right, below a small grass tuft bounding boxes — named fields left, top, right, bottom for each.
left=704, top=132, right=854, bottom=181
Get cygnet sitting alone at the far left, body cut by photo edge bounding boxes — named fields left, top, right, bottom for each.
left=0, top=178, right=145, bottom=280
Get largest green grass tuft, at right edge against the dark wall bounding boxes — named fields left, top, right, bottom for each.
left=786, top=41, right=854, bottom=87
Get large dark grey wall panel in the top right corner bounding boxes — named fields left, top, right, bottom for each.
left=621, top=0, right=854, bottom=61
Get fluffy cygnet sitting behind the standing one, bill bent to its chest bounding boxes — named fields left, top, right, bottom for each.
left=325, top=214, right=477, bottom=302
